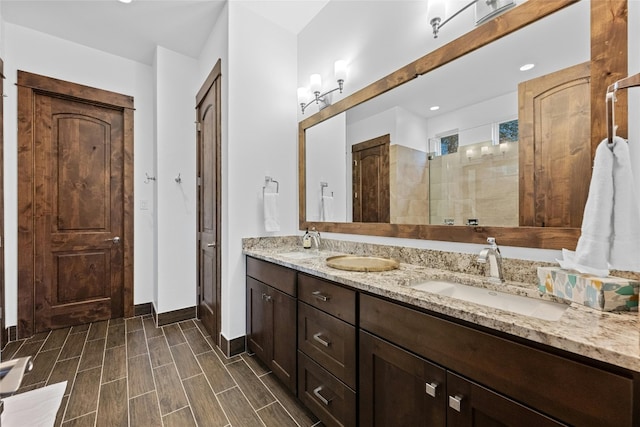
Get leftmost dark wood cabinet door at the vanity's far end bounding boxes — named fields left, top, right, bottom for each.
left=247, top=277, right=273, bottom=363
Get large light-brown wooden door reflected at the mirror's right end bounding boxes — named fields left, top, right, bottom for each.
left=518, top=62, right=591, bottom=228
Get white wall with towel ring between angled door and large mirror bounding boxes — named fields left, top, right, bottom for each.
left=215, top=2, right=299, bottom=339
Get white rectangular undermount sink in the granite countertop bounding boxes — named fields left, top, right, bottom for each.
left=411, top=280, right=569, bottom=321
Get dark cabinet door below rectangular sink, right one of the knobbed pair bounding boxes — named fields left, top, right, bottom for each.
left=447, top=372, right=565, bottom=427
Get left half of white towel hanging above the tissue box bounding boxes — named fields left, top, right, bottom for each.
left=558, top=139, right=613, bottom=276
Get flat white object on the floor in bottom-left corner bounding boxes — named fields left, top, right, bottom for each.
left=2, top=381, right=67, bottom=427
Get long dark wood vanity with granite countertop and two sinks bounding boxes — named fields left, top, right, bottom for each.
left=244, top=238, right=640, bottom=426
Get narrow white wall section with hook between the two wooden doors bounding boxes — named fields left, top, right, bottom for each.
left=153, top=46, right=200, bottom=313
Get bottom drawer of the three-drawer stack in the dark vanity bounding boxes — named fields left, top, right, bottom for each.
left=298, top=351, right=356, bottom=426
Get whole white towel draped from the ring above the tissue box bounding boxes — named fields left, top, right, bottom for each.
left=558, top=137, right=640, bottom=276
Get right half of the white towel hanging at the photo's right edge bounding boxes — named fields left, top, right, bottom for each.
left=609, top=137, right=640, bottom=271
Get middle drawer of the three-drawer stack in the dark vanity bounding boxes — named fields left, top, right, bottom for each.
left=298, top=301, right=356, bottom=389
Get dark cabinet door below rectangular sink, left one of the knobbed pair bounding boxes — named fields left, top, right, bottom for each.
left=358, top=331, right=446, bottom=427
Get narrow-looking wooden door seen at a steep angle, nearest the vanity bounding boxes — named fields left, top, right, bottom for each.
left=196, top=61, right=221, bottom=345
